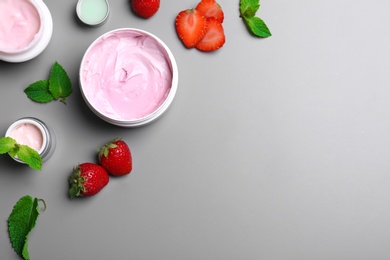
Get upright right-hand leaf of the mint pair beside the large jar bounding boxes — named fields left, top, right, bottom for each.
left=49, top=62, right=72, bottom=103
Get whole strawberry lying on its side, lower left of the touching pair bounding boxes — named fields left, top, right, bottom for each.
left=69, top=162, right=109, bottom=198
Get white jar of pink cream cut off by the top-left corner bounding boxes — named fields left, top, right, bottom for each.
left=0, top=0, right=53, bottom=62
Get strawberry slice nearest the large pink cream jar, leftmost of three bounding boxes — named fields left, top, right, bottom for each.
left=175, top=9, right=206, bottom=48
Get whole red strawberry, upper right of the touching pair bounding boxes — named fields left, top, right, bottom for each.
left=98, top=138, right=133, bottom=176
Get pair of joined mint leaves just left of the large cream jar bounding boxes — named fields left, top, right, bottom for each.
left=24, top=61, right=72, bottom=104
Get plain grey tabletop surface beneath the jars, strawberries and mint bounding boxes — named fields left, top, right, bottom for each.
left=0, top=0, right=390, bottom=260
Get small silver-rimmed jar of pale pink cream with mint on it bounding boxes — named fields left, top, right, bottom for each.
left=5, top=117, right=56, bottom=163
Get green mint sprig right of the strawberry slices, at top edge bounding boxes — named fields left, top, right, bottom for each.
left=240, top=0, right=271, bottom=38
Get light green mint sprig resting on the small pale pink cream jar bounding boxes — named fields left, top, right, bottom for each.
left=0, top=137, right=42, bottom=171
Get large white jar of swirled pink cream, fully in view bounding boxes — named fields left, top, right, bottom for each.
left=80, top=29, right=178, bottom=127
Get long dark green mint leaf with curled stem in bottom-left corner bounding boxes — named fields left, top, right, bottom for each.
left=8, top=195, right=46, bottom=260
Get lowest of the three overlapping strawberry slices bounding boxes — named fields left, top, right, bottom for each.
left=195, top=18, right=225, bottom=51
